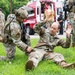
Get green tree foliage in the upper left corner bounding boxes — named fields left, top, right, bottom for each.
left=0, top=0, right=29, bottom=16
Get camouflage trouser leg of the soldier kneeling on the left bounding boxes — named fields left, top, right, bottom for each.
left=0, top=43, right=16, bottom=60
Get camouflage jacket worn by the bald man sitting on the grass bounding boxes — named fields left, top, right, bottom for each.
left=34, top=22, right=71, bottom=51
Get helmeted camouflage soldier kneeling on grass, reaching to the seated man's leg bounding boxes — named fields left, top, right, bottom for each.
left=0, top=7, right=31, bottom=60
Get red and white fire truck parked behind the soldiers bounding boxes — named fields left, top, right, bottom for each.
left=24, top=0, right=56, bottom=35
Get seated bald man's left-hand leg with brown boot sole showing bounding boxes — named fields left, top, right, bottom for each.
left=26, top=51, right=45, bottom=70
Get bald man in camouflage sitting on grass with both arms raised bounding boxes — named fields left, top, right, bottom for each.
left=26, top=22, right=75, bottom=70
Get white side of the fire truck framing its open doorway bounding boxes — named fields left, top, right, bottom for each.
left=36, top=0, right=56, bottom=22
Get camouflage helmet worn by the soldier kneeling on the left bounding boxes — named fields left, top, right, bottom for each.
left=15, top=7, right=28, bottom=19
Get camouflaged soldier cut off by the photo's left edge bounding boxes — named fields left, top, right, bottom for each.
left=0, top=8, right=5, bottom=41
